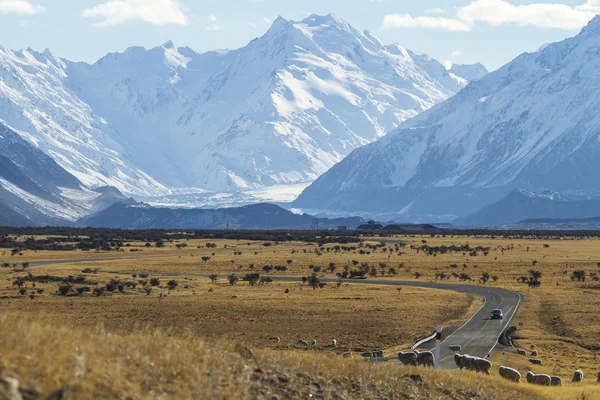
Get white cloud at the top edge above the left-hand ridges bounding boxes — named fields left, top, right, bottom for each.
left=82, top=0, right=188, bottom=28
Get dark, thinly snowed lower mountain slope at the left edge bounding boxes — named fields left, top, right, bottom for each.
left=0, top=121, right=126, bottom=225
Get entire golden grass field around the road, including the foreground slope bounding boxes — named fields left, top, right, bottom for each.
left=0, top=236, right=600, bottom=399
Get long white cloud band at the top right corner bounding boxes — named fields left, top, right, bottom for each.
left=382, top=0, right=600, bottom=32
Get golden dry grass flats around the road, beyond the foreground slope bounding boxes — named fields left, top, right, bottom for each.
left=0, top=236, right=600, bottom=399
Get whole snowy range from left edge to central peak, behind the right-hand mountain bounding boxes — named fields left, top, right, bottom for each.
left=0, top=15, right=481, bottom=219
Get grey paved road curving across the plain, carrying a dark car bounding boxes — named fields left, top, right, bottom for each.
left=31, top=257, right=521, bottom=369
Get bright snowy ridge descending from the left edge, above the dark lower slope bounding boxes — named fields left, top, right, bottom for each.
left=0, top=47, right=166, bottom=195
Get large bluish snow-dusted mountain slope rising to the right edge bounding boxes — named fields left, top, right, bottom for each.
left=295, top=17, right=600, bottom=219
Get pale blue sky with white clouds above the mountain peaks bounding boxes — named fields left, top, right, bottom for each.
left=0, top=0, right=600, bottom=69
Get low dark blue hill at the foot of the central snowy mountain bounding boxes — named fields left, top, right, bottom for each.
left=77, top=203, right=366, bottom=229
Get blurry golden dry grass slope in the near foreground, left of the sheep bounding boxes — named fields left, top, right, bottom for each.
left=0, top=316, right=556, bottom=400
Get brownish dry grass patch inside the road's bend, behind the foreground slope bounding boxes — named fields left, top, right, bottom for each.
left=0, top=274, right=478, bottom=350
